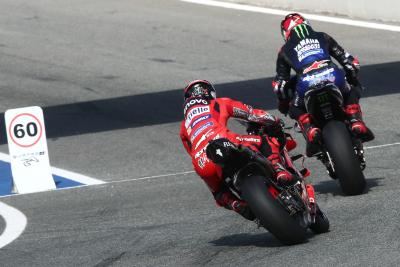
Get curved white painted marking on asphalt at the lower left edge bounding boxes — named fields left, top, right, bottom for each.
left=0, top=202, right=28, bottom=248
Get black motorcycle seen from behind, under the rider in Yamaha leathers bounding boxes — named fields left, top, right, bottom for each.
left=304, top=83, right=366, bottom=195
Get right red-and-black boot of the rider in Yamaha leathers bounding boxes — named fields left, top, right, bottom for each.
left=345, top=104, right=375, bottom=142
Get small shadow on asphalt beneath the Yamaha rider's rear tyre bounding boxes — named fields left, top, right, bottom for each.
left=313, top=177, right=384, bottom=196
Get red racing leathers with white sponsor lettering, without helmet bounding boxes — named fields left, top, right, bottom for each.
left=180, top=98, right=283, bottom=215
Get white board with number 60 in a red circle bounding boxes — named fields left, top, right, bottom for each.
left=5, top=107, right=55, bottom=193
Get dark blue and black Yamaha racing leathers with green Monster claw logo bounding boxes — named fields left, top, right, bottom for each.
left=272, top=24, right=359, bottom=119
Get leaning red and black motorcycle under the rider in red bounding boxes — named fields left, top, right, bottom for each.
left=206, top=123, right=329, bottom=245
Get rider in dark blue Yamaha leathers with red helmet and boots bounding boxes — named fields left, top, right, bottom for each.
left=272, top=13, right=374, bottom=156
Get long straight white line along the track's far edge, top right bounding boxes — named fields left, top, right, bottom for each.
left=181, top=0, right=400, bottom=32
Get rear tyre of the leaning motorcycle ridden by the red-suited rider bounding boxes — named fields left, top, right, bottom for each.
left=241, top=176, right=307, bottom=245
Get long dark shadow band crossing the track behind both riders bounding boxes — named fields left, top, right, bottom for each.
left=0, top=62, right=400, bottom=144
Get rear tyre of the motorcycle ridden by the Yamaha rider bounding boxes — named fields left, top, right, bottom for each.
left=322, top=120, right=366, bottom=195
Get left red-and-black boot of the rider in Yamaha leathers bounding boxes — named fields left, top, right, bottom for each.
left=297, top=113, right=322, bottom=157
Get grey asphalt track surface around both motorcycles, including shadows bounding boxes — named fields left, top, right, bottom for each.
left=0, top=0, right=400, bottom=266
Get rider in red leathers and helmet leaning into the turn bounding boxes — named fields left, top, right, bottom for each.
left=180, top=80, right=293, bottom=220
